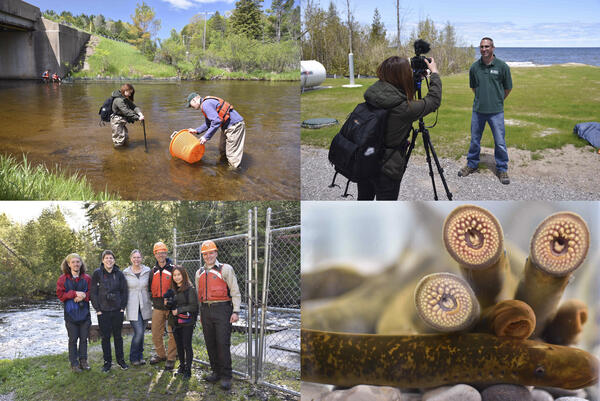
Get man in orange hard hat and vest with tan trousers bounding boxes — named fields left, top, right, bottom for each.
left=148, top=242, right=177, bottom=370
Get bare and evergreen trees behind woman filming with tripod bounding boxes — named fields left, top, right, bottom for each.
left=301, top=0, right=475, bottom=76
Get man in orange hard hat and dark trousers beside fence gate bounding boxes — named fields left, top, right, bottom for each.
left=195, top=241, right=242, bottom=390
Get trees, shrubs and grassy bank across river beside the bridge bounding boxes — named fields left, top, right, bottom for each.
left=44, top=0, right=300, bottom=80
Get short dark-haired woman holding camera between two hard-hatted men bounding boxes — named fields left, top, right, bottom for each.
left=165, top=266, right=198, bottom=379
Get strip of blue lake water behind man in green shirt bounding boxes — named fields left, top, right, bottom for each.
left=492, top=47, right=600, bottom=66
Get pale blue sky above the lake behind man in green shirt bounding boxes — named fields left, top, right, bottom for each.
left=328, top=0, right=600, bottom=47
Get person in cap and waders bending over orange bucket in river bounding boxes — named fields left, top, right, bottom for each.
left=187, top=92, right=246, bottom=169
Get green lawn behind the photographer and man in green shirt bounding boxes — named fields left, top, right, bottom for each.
left=301, top=66, right=600, bottom=159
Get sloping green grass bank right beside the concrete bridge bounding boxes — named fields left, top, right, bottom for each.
left=73, top=37, right=177, bottom=78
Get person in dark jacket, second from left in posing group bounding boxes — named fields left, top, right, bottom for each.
left=91, top=249, right=129, bottom=373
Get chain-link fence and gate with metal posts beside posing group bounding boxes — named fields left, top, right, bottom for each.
left=173, top=208, right=300, bottom=396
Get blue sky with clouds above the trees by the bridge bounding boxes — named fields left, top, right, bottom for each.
left=25, top=0, right=278, bottom=39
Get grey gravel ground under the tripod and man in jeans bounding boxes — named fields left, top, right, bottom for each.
left=301, top=145, right=600, bottom=200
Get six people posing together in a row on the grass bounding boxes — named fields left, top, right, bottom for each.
left=56, top=240, right=241, bottom=390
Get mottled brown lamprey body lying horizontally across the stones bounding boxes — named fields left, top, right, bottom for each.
left=301, top=329, right=598, bottom=389
